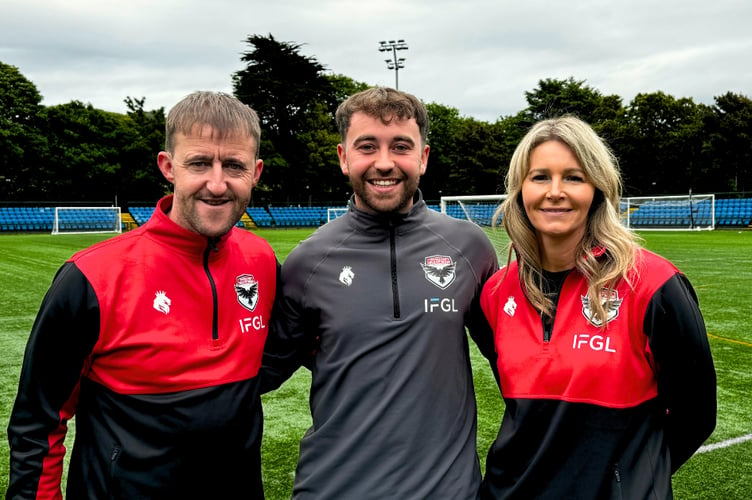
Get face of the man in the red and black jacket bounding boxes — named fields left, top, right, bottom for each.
left=157, top=125, right=263, bottom=237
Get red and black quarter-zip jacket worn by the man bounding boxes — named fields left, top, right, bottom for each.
left=7, top=196, right=278, bottom=499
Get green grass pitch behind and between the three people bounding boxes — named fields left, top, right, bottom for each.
left=0, top=229, right=752, bottom=500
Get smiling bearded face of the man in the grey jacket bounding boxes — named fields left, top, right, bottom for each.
left=337, top=112, right=429, bottom=213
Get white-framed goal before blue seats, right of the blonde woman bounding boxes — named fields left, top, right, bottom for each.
left=620, top=194, right=715, bottom=231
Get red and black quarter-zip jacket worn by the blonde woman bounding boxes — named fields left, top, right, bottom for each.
left=481, top=250, right=716, bottom=500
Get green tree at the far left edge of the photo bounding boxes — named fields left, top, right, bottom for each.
left=0, top=62, right=47, bottom=201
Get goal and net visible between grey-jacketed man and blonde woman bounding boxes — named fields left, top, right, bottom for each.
left=440, top=194, right=509, bottom=263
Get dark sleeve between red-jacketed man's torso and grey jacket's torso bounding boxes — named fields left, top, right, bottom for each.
left=261, top=260, right=318, bottom=394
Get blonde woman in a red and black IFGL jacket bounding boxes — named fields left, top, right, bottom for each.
left=481, top=116, right=716, bottom=499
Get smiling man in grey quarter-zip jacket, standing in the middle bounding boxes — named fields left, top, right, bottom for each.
left=262, top=88, right=498, bottom=500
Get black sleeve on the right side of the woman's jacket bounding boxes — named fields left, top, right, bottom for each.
left=644, top=274, right=717, bottom=472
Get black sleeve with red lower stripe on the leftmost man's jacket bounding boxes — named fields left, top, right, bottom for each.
left=6, top=263, right=99, bottom=499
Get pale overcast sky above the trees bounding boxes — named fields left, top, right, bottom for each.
left=0, top=0, right=752, bottom=121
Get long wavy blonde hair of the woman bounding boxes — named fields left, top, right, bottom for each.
left=494, top=116, right=638, bottom=327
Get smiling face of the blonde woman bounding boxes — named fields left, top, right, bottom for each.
left=521, top=140, right=595, bottom=253
